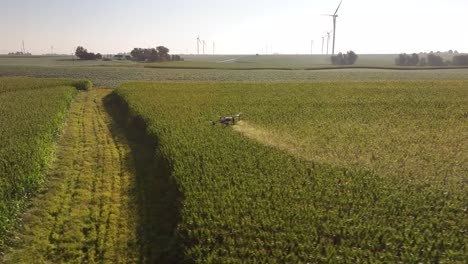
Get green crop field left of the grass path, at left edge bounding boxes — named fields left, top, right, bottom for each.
left=0, top=78, right=77, bottom=246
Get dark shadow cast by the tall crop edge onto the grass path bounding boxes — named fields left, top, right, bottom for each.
left=103, top=93, right=186, bottom=263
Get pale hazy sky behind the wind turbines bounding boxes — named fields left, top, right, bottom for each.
left=0, top=0, right=468, bottom=54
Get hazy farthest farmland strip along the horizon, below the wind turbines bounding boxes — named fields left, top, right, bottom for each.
left=0, top=54, right=460, bottom=70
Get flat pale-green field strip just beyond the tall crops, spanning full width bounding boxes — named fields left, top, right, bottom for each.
left=0, top=65, right=468, bottom=87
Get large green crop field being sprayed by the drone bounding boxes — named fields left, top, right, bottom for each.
left=115, top=82, right=468, bottom=263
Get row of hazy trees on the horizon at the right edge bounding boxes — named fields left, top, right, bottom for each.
left=395, top=52, right=468, bottom=67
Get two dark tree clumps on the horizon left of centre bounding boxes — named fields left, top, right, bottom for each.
left=75, top=46, right=183, bottom=62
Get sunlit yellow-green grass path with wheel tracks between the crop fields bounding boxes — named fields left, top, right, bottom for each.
left=4, top=90, right=142, bottom=263
